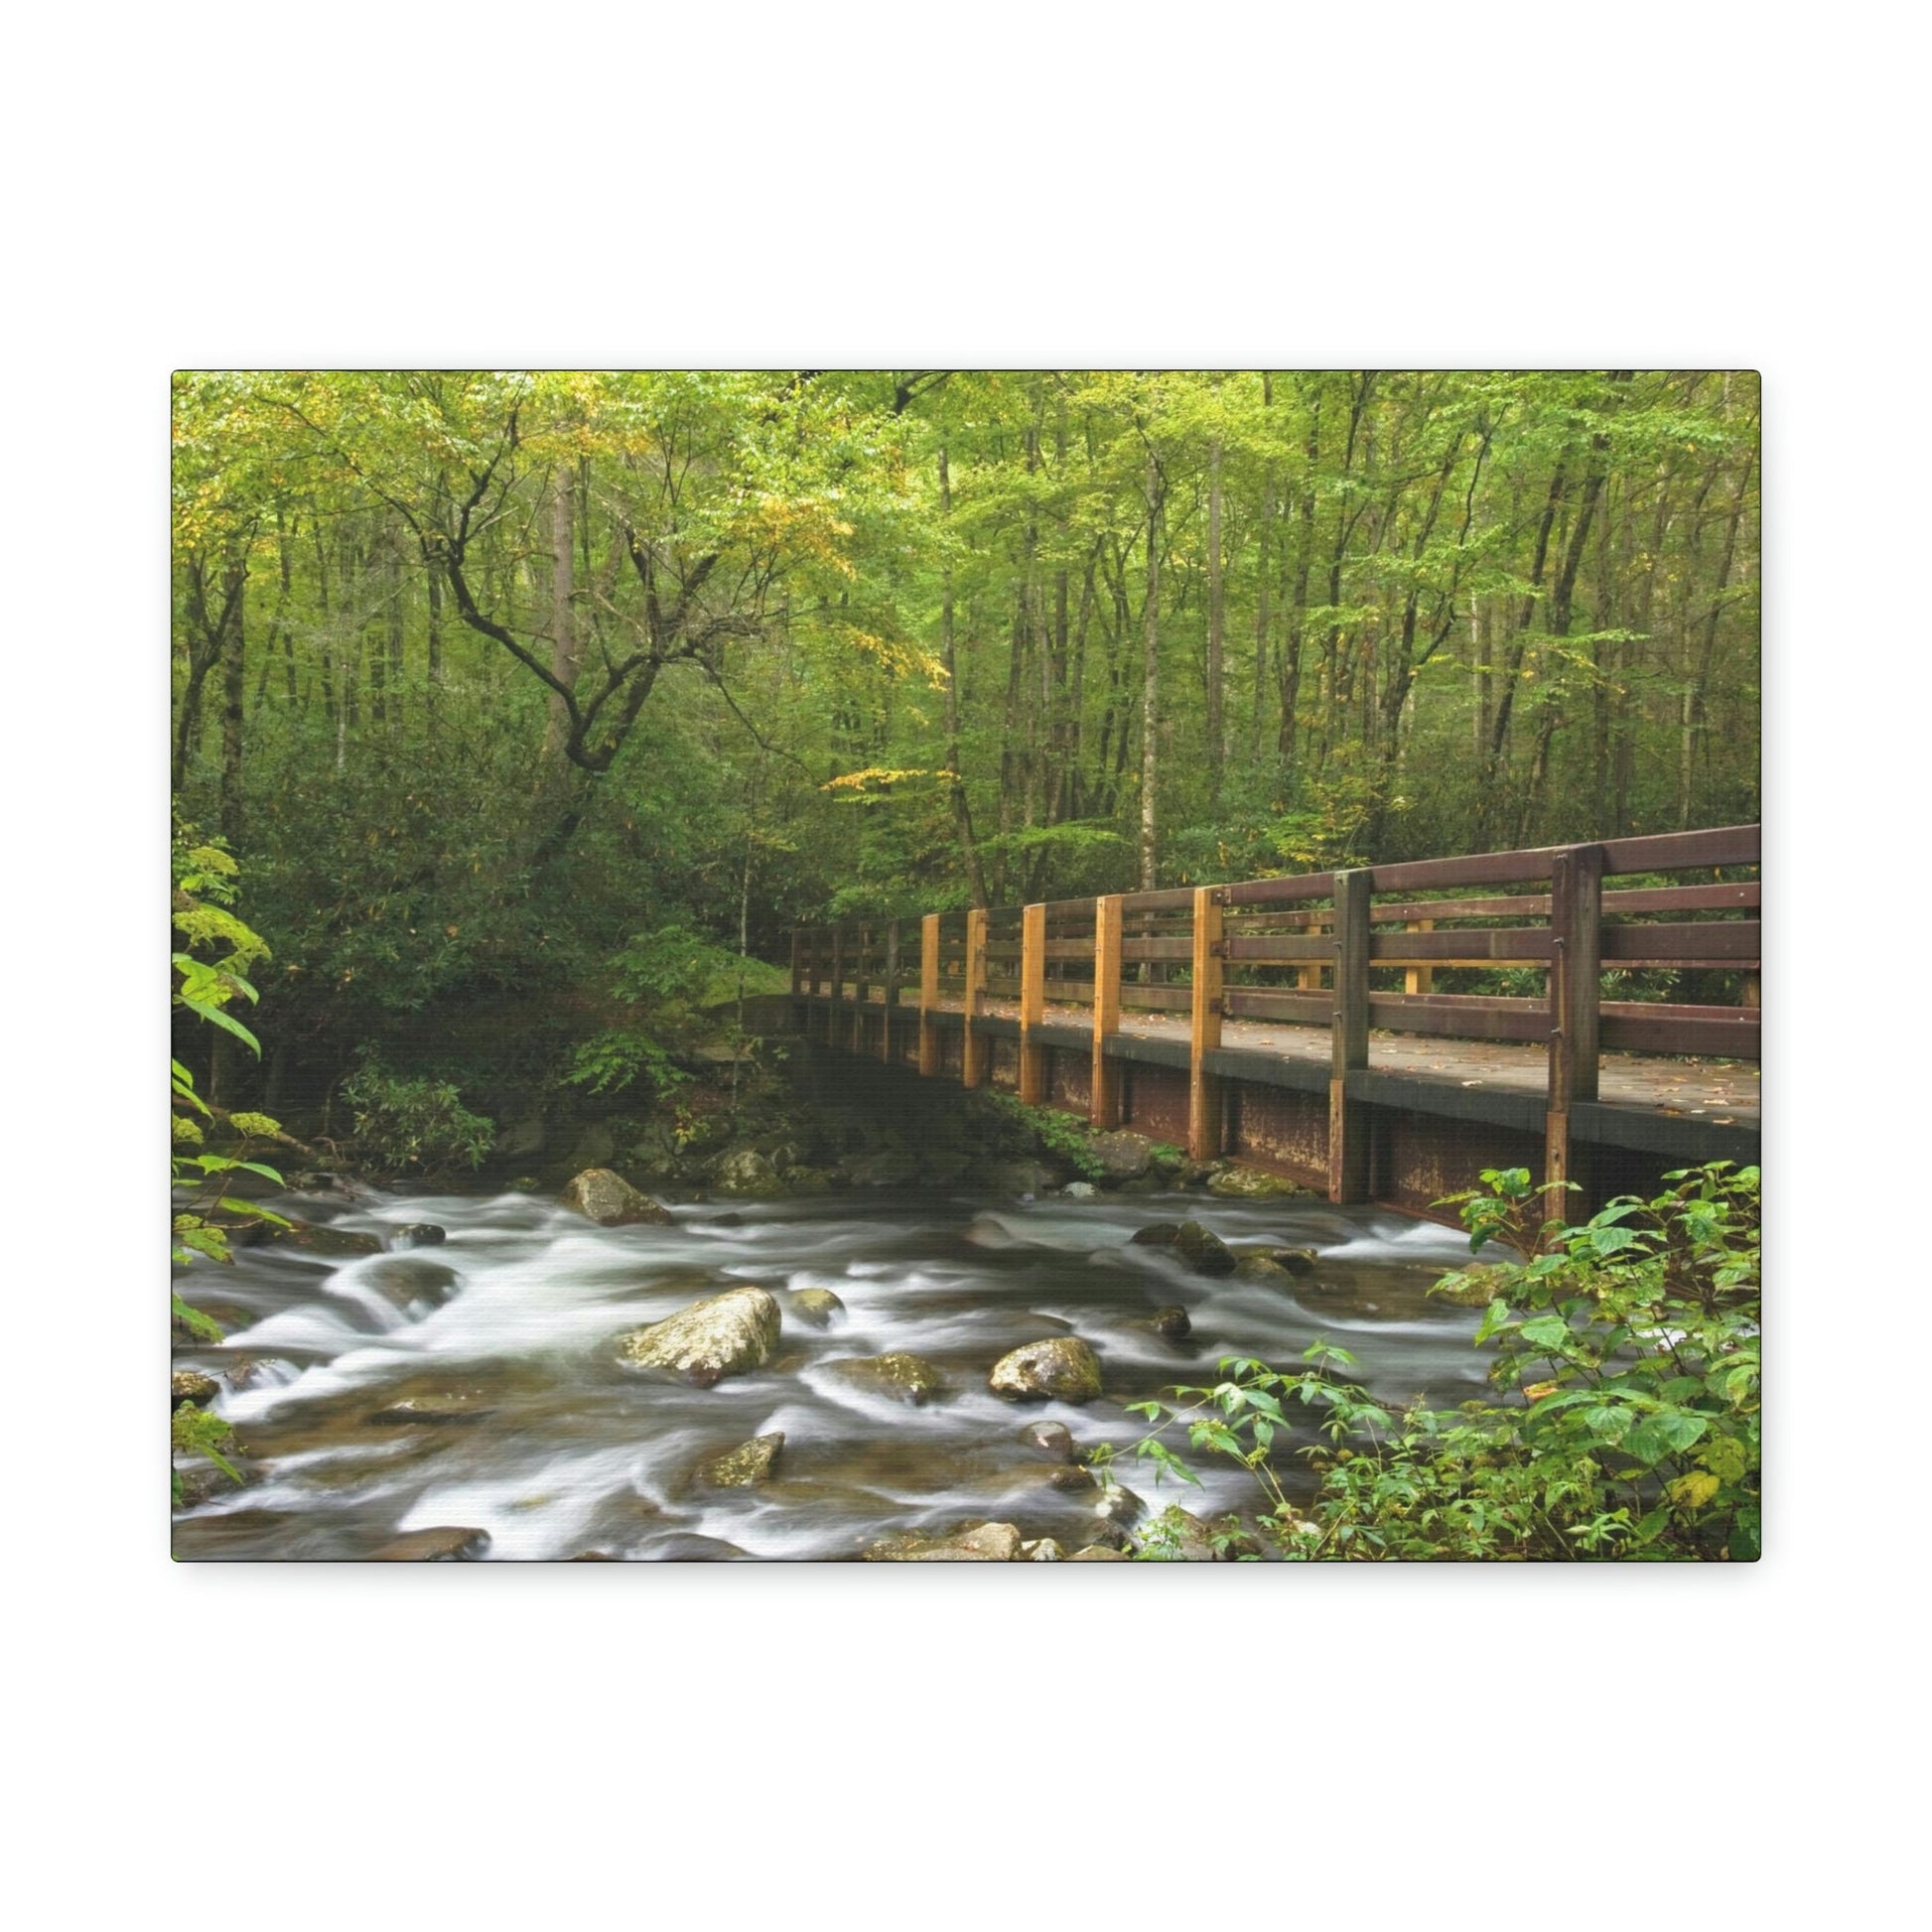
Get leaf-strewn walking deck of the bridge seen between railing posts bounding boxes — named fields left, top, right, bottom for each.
left=822, top=991, right=1762, bottom=1132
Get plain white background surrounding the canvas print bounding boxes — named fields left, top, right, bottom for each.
left=0, top=4, right=1932, bottom=1928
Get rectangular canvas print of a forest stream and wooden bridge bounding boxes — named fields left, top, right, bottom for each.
left=168, top=369, right=1762, bottom=1563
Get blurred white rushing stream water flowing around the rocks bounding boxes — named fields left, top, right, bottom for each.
left=174, top=1192, right=1484, bottom=1561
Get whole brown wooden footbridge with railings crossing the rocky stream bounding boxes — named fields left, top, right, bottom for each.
left=786, top=825, right=1760, bottom=1215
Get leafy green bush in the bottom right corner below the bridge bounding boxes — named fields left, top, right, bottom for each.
left=1130, top=1162, right=1762, bottom=1561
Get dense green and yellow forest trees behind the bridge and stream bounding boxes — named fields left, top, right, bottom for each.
left=172, top=371, right=1760, bottom=1125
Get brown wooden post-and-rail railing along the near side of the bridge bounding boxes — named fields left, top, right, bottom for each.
left=792, top=825, right=1760, bottom=1198
